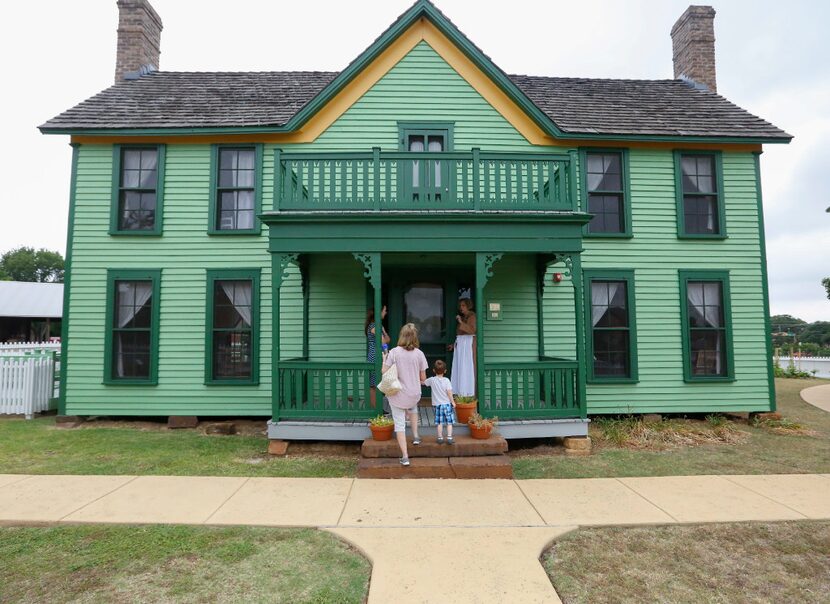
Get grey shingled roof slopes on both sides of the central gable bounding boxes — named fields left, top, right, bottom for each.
left=40, top=71, right=791, bottom=139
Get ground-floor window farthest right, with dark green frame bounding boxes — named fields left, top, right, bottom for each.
left=680, top=271, right=734, bottom=381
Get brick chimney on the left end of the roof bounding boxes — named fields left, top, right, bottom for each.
left=115, top=0, right=162, bottom=84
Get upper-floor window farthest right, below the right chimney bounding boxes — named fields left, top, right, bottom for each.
left=675, top=151, right=726, bottom=238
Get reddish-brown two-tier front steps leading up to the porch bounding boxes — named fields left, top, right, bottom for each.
left=357, top=435, right=513, bottom=479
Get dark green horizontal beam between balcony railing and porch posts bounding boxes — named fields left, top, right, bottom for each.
left=260, top=211, right=591, bottom=253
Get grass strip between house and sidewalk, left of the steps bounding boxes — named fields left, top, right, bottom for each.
left=0, top=417, right=357, bottom=477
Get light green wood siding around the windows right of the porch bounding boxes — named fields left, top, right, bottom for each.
left=583, top=149, right=770, bottom=413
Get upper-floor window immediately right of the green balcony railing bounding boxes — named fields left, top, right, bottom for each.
left=582, top=150, right=631, bottom=237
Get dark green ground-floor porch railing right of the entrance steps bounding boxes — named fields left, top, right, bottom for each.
left=479, top=358, right=585, bottom=419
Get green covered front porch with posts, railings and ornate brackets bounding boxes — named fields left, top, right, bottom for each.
left=266, top=222, right=587, bottom=440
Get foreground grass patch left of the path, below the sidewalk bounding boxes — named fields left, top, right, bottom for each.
left=0, top=526, right=371, bottom=604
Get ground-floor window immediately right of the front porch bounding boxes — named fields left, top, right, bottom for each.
left=586, top=271, right=636, bottom=381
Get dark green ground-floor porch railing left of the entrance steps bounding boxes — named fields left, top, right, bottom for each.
left=278, top=359, right=376, bottom=420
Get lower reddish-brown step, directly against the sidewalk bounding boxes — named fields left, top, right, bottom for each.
left=357, top=454, right=513, bottom=479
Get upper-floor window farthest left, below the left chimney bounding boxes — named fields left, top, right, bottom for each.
left=110, top=145, right=164, bottom=235
